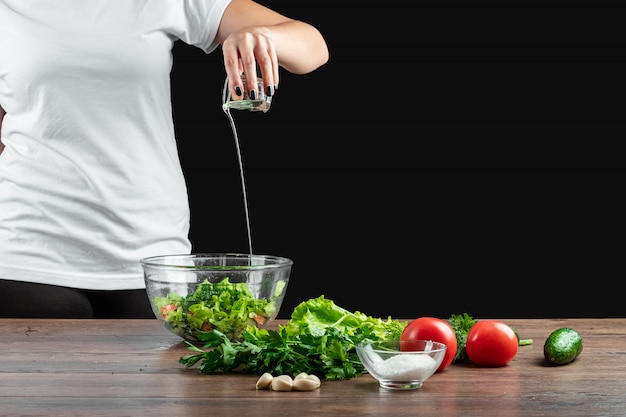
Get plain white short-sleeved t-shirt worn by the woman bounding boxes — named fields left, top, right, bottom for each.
left=0, top=0, right=229, bottom=290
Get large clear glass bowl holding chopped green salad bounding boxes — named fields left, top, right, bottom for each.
left=141, top=253, right=293, bottom=344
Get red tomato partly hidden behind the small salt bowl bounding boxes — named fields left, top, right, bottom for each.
left=400, top=317, right=458, bottom=372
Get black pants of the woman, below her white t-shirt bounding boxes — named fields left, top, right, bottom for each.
left=0, top=279, right=155, bottom=319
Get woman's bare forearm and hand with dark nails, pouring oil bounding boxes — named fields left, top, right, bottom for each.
left=216, top=0, right=329, bottom=98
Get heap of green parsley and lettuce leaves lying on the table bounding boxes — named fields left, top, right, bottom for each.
left=179, top=296, right=407, bottom=380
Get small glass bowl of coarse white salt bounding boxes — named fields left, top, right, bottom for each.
left=356, top=340, right=447, bottom=390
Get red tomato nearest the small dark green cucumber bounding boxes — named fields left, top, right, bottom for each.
left=465, top=320, right=518, bottom=367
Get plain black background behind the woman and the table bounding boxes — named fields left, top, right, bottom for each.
left=172, top=0, right=626, bottom=318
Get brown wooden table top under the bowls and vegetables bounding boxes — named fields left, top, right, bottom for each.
left=0, top=318, right=626, bottom=417
